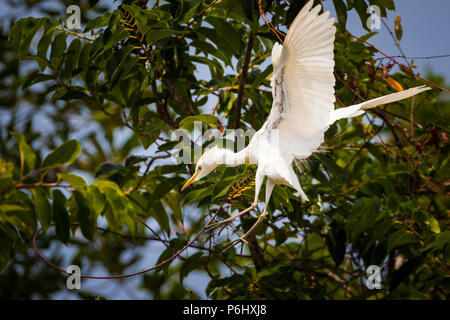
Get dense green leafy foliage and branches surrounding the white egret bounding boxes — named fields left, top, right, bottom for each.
left=0, top=0, right=450, bottom=299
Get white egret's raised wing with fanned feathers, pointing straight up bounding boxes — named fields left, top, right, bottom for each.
left=263, top=0, right=336, bottom=158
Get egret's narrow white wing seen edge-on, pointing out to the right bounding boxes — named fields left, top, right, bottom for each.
left=330, top=85, right=431, bottom=125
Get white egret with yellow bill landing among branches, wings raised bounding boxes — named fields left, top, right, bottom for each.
left=182, top=0, right=430, bottom=245
